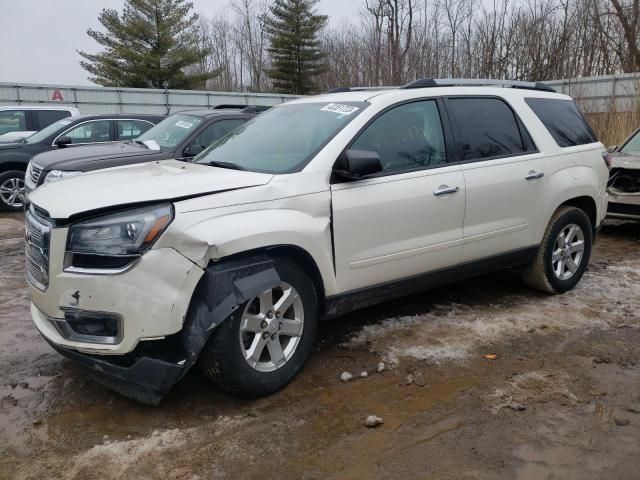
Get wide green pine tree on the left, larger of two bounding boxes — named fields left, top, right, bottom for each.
left=78, top=0, right=214, bottom=89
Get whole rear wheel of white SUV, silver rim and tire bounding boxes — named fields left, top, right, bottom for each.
left=523, top=207, right=593, bottom=293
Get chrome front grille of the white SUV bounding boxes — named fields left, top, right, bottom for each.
left=24, top=210, right=51, bottom=290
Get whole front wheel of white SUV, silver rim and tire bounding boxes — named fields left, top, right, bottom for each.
left=199, top=258, right=318, bottom=397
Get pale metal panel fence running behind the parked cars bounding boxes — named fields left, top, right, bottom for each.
left=0, top=73, right=640, bottom=114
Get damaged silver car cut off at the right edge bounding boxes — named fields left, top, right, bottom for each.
left=607, top=128, right=640, bottom=220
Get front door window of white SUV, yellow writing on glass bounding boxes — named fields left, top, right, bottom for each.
left=350, top=100, right=447, bottom=172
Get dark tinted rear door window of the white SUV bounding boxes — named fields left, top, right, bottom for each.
left=447, top=97, right=534, bottom=161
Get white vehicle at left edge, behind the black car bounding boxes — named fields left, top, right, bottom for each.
left=0, top=105, right=80, bottom=143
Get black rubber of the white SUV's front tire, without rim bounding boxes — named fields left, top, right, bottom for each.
left=198, top=257, right=318, bottom=397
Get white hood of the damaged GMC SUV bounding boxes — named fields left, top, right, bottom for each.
left=29, top=160, right=273, bottom=219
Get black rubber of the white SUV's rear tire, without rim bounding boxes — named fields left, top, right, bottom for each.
left=522, top=206, right=593, bottom=293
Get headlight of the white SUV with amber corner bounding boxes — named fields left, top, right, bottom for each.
left=65, top=204, right=173, bottom=269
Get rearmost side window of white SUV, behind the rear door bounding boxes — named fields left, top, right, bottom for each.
left=525, top=98, right=598, bottom=147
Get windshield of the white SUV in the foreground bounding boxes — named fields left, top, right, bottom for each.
left=194, top=102, right=368, bottom=173
